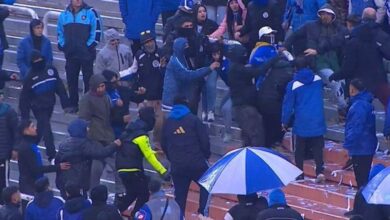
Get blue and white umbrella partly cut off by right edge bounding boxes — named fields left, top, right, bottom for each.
left=362, top=167, right=390, bottom=205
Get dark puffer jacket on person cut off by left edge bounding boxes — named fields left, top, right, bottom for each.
left=0, top=102, right=18, bottom=160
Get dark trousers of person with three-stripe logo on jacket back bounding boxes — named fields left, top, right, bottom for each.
left=172, top=166, right=209, bottom=216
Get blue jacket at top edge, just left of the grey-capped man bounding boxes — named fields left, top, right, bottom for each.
left=284, top=0, right=326, bottom=31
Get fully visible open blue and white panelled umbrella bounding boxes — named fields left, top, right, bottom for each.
left=199, top=147, right=302, bottom=195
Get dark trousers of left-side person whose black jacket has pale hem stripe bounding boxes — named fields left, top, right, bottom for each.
left=32, top=107, right=56, bottom=159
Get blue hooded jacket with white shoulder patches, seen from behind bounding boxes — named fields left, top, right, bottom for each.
left=282, top=69, right=326, bottom=137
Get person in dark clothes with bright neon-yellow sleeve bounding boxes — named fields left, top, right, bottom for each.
left=116, top=107, right=170, bottom=217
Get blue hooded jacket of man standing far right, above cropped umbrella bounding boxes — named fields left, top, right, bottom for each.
left=344, top=91, right=378, bottom=156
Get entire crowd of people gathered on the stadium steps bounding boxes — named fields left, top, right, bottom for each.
left=0, top=0, right=390, bottom=220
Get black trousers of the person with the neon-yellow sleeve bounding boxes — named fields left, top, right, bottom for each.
left=118, top=172, right=149, bottom=217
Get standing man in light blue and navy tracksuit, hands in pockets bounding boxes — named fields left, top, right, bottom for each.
left=57, top=0, right=103, bottom=112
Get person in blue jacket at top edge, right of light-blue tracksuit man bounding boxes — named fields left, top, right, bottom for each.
left=119, top=0, right=161, bottom=54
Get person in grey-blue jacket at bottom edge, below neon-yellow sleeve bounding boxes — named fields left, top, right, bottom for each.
left=135, top=179, right=184, bottom=220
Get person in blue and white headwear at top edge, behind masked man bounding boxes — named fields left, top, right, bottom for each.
left=163, top=0, right=194, bottom=43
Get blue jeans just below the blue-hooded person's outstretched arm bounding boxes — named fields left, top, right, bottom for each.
left=202, top=71, right=218, bottom=112
